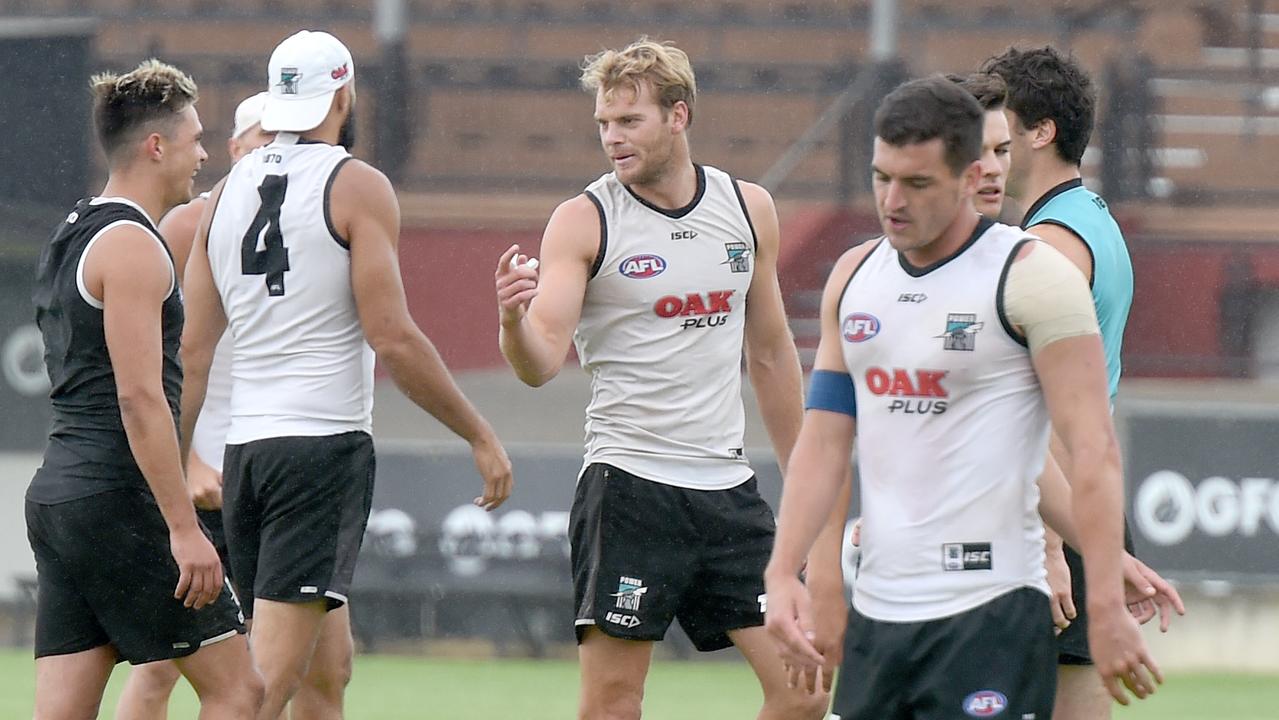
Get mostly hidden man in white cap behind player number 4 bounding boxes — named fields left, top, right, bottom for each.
left=115, top=92, right=275, bottom=720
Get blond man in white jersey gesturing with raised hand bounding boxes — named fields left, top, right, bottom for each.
left=495, top=38, right=826, bottom=719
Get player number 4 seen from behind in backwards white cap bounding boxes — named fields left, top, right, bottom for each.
left=183, top=31, right=512, bottom=720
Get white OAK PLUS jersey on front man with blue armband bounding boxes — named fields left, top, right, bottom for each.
left=839, top=220, right=1049, bottom=622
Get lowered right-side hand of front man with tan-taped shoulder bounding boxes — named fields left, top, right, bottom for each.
left=1088, top=604, right=1164, bottom=705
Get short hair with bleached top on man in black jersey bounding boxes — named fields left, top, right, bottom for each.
left=90, top=59, right=200, bottom=161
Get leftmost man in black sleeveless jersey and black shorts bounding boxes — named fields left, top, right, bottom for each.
left=26, top=60, right=262, bottom=720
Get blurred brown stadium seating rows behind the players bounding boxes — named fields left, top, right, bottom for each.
left=15, top=0, right=1279, bottom=381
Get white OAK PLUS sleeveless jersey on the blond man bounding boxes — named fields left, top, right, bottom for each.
left=574, top=166, right=756, bottom=490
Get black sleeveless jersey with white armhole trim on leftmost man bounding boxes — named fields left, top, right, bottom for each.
left=27, top=198, right=183, bottom=504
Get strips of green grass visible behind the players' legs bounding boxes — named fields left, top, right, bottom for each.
left=0, top=651, right=1279, bottom=720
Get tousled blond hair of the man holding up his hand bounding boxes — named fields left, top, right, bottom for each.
left=582, top=37, right=697, bottom=124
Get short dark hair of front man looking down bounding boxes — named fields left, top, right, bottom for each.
left=875, top=75, right=985, bottom=175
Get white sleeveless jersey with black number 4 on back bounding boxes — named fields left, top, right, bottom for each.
left=208, top=133, right=373, bottom=445
